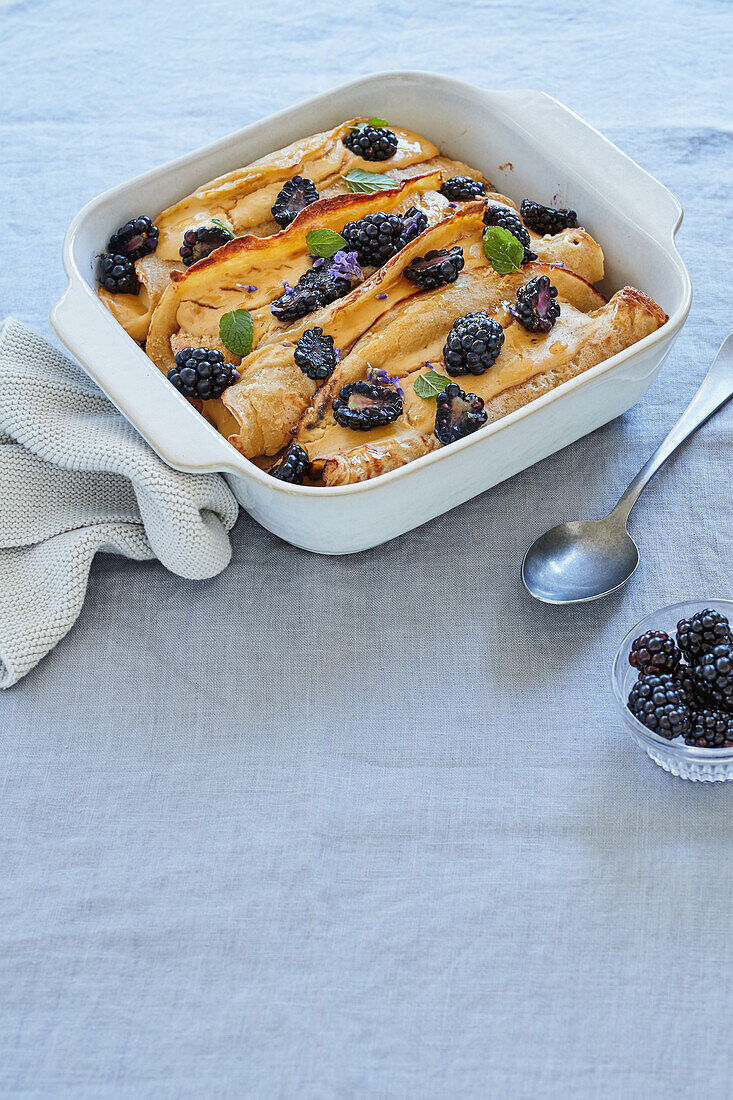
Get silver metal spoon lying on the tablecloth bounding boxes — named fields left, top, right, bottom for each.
left=522, top=332, right=733, bottom=604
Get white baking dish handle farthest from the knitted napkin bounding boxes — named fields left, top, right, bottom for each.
left=489, top=89, right=682, bottom=245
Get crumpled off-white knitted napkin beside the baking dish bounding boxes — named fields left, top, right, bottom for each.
left=0, top=319, right=238, bottom=688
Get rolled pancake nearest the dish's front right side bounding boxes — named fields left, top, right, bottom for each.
left=298, top=288, right=667, bottom=485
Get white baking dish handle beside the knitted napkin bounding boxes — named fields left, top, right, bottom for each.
left=50, top=281, right=246, bottom=474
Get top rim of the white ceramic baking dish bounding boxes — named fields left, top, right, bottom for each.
left=51, top=69, right=692, bottom=498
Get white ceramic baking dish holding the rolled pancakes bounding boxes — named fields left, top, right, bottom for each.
left=51, top=73, right=691, bottom=554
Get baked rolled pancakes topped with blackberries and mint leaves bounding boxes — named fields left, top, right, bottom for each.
left=98, top=119, right=667, bottom=485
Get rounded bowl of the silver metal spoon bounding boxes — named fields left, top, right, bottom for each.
left=522, top=515, right=638, bottom=604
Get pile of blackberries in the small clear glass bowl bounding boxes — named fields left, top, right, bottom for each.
left=628, top=607, right=733, bottom=748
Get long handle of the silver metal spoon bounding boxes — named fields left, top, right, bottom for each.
left=611, top=332, right=733, bottom=521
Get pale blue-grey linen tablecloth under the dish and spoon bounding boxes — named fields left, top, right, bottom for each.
left=0, top=0, right=733, bottom=1100
